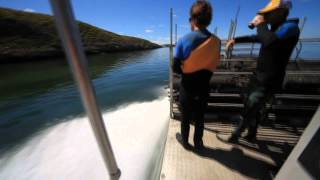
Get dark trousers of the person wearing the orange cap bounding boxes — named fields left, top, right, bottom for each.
left=233, top=79, right=274, bottom=137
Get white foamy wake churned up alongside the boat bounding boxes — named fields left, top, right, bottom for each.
left=0, top=98, right=169, bottom=180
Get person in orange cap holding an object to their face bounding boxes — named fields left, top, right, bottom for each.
left=217, top=0, right=300, bottom=142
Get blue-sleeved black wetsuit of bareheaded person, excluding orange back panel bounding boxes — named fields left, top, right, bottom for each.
left=172, top=29, right=212, bottom=146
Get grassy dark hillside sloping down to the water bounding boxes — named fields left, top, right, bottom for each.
left=0, top=8, right=161, bottom=63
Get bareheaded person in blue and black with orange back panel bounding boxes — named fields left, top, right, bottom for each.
left=172, top=0, right=220, bottom=149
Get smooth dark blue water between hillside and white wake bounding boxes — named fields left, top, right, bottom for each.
left=0, top=49, right=168, bottom=151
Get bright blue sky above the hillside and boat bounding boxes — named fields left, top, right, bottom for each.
left=0, top=0, right=320, bottom=43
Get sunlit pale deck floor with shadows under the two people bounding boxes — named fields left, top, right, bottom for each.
left=160, top=119, right=305, bottom=180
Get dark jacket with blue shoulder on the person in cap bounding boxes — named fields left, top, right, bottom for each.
left=235, top=19, right=300, bottom=90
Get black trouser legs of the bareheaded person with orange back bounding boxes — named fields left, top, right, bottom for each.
left=179, top=85, right=209, bottom=144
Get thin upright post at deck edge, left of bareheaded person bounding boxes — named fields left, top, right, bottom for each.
left=169, top=8, right=173, bottom=118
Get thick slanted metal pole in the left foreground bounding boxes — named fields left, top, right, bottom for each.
left=50, top=0, right=121, bottom=180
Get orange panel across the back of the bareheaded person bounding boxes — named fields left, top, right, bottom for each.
left=181, top=36, right=221, bottom=74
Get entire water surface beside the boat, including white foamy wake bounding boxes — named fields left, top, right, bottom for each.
left=0, top=48, right=169, bottom=180
